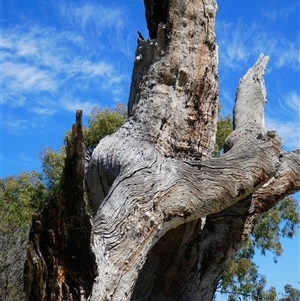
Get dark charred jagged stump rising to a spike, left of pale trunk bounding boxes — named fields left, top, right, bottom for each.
left=24, top=111, right=96, bottom=301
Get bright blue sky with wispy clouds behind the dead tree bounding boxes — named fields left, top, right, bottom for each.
left=0, top=0, right=300, bottom=296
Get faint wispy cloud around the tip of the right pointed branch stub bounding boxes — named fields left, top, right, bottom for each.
left=217, top=20, right=300, bottom=70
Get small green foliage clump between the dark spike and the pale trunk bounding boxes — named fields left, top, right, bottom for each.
left=83, top=104, right=127, bottom=149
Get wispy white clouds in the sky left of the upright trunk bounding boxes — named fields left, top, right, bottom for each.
left=1, top=3, right=128, bottom=132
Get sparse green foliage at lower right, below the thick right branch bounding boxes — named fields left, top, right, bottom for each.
left=219, top=197, right=300, bottom=301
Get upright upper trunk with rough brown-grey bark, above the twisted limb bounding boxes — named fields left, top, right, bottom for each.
left=128, top=0, right=218, bottom=159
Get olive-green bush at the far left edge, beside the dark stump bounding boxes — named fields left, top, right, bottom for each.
left=0, top=171, right=47, bottom=301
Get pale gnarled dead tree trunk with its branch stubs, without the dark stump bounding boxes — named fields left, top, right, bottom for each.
left=24, top=0, right=300, bottom=301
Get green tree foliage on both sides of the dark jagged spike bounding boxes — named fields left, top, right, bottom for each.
left=0, top=105, right=126, bottom=301
